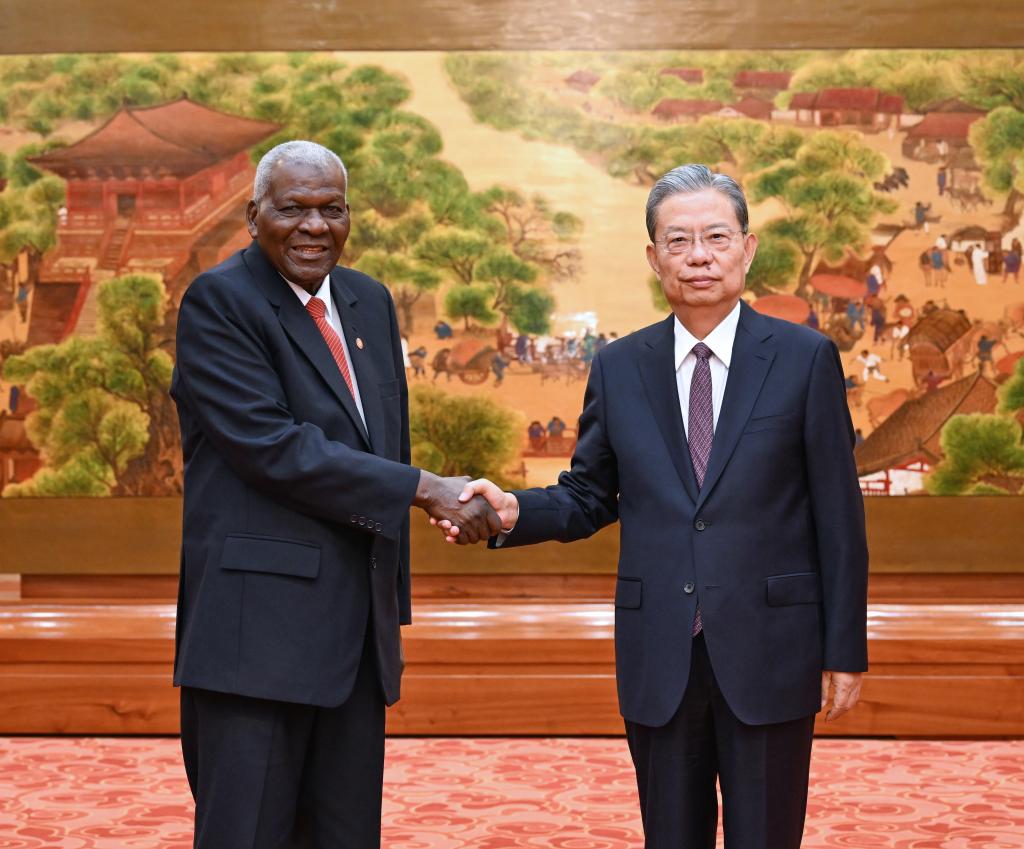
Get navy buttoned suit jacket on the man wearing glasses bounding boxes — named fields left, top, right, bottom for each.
left=503, top=304, right=867, bottom=726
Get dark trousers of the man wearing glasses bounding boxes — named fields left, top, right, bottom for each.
left=626, top=634, right=814, bottom=849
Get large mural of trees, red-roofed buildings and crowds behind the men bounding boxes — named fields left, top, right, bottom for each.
left=0, top=50, right=1024, bottom=498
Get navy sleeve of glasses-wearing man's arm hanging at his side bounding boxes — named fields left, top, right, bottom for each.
left=804, top=339, right=867, bottom=672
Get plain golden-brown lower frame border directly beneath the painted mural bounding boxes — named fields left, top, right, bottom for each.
left=0, top=496, right=1024, bottom=576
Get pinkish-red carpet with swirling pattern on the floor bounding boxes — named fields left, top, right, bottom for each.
left=0, top=737, right=1024, bottom=849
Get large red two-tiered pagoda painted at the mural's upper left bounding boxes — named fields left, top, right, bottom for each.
left=30, top=96, right=280, bottom=285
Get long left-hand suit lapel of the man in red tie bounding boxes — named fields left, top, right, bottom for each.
left=243, top=243, right=376, bottom=447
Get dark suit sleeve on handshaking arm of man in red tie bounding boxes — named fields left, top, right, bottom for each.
left=175, top=274, right=419, bottom=544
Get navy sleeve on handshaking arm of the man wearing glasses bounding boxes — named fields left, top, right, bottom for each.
left=489, top=354, right=618, bottom=548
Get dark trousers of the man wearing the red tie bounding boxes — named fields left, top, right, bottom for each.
left=181, top=639, right=384, bottom=849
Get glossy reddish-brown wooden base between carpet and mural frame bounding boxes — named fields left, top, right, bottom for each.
left=0, top=601, right=1024, bottom=736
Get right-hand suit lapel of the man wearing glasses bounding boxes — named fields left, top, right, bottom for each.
left=697, top=303, right=775, bottom=510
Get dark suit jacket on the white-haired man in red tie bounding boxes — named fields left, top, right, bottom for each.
left=171, top=243, right=419, bottom=706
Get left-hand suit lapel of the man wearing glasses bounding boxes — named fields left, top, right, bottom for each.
left=637, top=315, right=697, bottom=501
